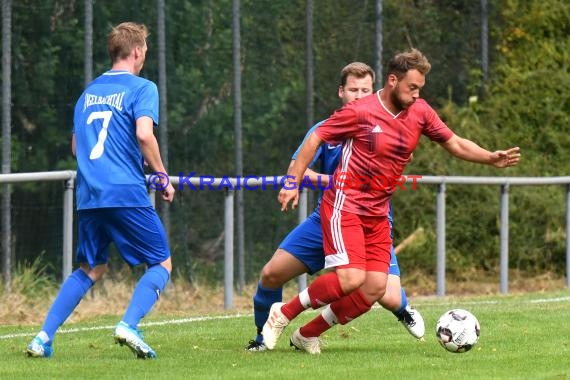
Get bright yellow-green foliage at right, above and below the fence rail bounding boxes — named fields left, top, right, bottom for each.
left=388, top=1, right=570, bottom=276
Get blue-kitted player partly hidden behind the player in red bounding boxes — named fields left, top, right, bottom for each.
left=246, top=62, right=425, bottom=351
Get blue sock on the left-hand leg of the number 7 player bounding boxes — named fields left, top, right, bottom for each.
left=42, top=269, right=93, bottom=342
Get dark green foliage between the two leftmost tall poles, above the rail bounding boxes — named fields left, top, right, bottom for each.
left=12, top=1, right=83, bottom=171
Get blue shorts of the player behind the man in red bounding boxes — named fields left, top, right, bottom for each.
left=279, top=210, right=400, bottom=277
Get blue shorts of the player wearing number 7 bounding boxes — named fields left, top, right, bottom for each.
left=76, top=207, right=170, bottom=268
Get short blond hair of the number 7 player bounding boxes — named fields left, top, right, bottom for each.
left=107, top=22, right=148, bottom=63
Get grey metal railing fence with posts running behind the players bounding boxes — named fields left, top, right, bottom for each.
left=0, top=170, right=570, bottom=309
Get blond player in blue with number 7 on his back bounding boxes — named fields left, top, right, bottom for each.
left=26, top=22, right=174, bottom=359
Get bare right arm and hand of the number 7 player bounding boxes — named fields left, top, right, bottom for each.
left=137, top=116, right=175, bottom=202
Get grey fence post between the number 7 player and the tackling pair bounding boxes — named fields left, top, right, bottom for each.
left=224, top=190, right=234, bottom=309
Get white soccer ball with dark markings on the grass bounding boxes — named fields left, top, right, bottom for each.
left=435, top=309, right=481, bottom=353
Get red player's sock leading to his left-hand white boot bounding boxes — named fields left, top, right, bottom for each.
left=281, top=272, right=344, bottom=320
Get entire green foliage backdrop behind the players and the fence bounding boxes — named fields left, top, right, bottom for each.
left=2, top=0, right=570, bottom=280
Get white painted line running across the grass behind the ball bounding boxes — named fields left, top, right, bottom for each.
left=0, top=296, right=570, bottom=340
